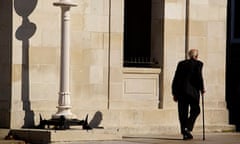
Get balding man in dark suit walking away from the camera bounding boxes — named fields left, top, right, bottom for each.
left=172, top=49, right=205, bottom=140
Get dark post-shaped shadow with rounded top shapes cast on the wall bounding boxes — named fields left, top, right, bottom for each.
left=14, top=0, right=37, bottom=128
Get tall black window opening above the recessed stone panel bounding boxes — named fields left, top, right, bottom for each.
left=124, top=0, right=158, bottom=67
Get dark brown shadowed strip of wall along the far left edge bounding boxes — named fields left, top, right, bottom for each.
left=0, top=0, right=12, bottom=128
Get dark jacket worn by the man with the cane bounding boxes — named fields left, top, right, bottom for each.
left=172, top=59, right=204, bottom=100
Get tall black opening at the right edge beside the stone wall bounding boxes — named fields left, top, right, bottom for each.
left=226, top=0, right=240, bottom=131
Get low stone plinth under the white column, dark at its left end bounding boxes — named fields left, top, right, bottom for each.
left=8, top=128, right=122, bottom=144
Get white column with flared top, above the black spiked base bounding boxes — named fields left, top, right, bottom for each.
left=53, top=0, right=77, bottom=118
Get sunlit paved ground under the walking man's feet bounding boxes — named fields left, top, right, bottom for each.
left=53, top=133, right=240, bottom=144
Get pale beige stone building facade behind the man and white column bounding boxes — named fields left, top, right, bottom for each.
left=0, top=0, right=232, bottom=134
